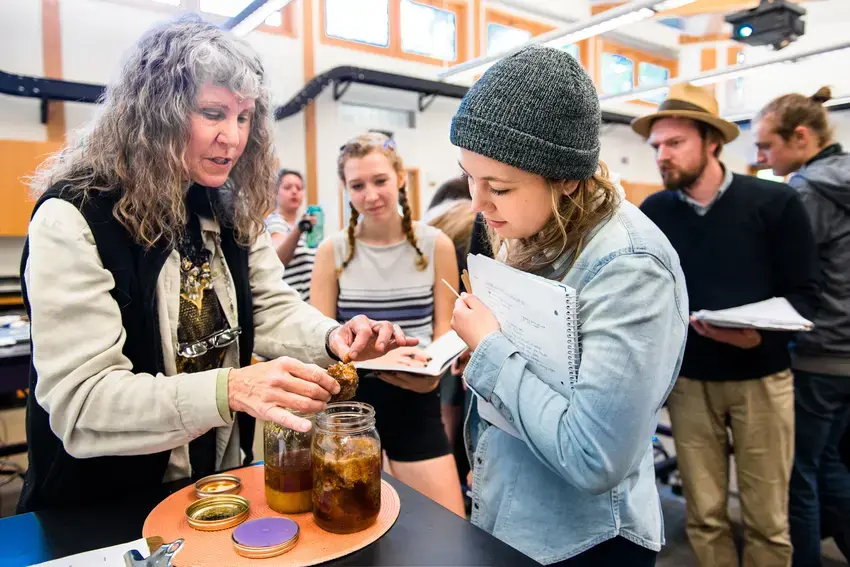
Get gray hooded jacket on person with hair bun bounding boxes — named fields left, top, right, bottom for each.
left=788, top=144, right=850, bottom=377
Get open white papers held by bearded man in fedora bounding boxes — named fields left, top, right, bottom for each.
left=693, top=297, right=814, bottom=331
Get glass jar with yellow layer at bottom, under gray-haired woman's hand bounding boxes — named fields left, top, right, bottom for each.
left=263, top=418, right=316, bottom=514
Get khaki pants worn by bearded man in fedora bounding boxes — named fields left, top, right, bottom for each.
left=668, top=370, right=794, bottom=567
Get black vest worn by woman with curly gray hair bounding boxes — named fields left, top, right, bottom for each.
left=18, top=185, right=254, bottom=513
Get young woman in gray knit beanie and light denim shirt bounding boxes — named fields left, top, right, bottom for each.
left=451, top=47, right=688, bottom=567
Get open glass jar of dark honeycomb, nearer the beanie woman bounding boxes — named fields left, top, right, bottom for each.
left=313, top=402, right=381, bottom=534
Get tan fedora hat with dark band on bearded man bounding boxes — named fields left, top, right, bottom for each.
left=632, top=83, right=741, bottom=144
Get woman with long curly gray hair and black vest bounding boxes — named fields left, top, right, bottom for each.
left=19, top=16, right=417, bottom=511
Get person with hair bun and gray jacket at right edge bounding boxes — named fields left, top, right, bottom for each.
left=753, top=87, right=850, bottom=567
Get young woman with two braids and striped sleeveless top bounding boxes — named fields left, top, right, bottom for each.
left=310, top=134, right=464, bottom=516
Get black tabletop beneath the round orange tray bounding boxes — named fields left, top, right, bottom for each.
left=0, top=470, right=539, bottom=567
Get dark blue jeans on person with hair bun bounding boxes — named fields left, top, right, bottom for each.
left=788, top=370, right=850, bottom=567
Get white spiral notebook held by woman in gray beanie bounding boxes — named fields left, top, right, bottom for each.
left=460, top=255, right=581, bottom=438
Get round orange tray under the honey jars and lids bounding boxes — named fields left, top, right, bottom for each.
left=142, top=465, right=401, bottom=567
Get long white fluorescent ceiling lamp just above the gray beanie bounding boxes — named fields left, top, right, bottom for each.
left=437, top=0, right=696, bottom=80
